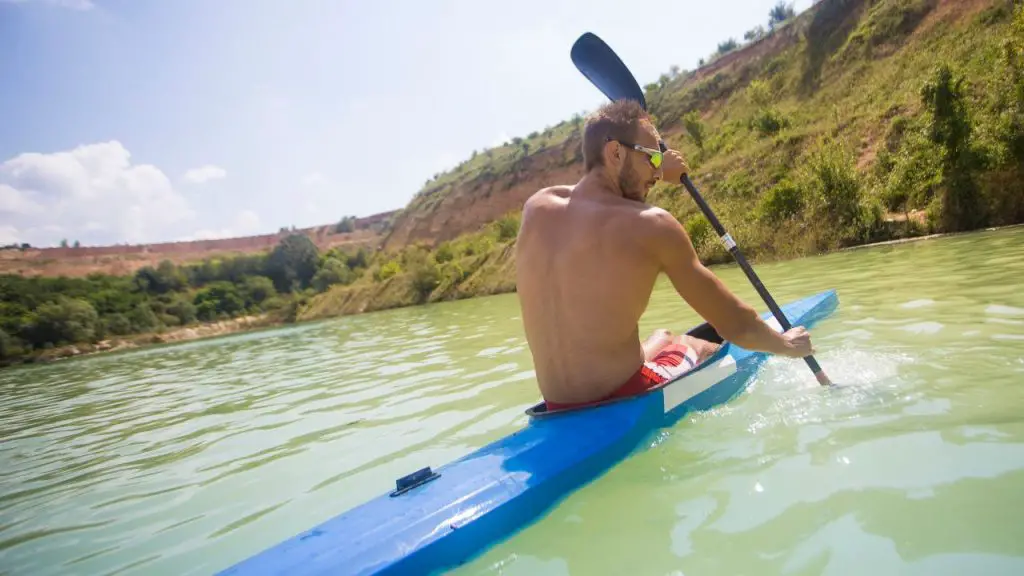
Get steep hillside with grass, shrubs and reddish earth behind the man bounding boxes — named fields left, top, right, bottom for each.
left=300, top=0, right=1024, bottom=318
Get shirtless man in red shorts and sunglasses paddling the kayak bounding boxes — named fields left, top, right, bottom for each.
left=516, top=100, right=812, bottom=410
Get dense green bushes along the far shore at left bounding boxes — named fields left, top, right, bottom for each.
left=0, top=235, right=369, bottom=364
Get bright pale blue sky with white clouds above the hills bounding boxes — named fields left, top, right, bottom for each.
left=0, top=0, right=811, bottom=246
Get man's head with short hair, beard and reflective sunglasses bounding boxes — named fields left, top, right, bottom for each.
left=583, top=99, right=662, bottom=202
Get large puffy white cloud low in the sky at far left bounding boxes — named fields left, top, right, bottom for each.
left=0, top=140, right=195, bottom=246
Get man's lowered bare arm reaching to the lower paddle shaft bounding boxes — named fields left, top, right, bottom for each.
left=644, top=208, right=811, bottom=358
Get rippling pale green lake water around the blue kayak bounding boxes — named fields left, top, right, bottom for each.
left=0, top=229, right=1024, bottom=576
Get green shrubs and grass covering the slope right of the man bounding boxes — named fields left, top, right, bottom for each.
left=648, top=0, right=1024, bottom=262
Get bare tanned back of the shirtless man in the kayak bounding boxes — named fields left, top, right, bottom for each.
left=516, top=187, right=712, bottom=403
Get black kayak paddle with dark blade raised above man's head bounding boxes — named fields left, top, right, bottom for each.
left=569, top=32, right=831, bottom=386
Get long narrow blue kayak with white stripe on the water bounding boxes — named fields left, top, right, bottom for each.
left=220, top=290, right=839, bottom=576
